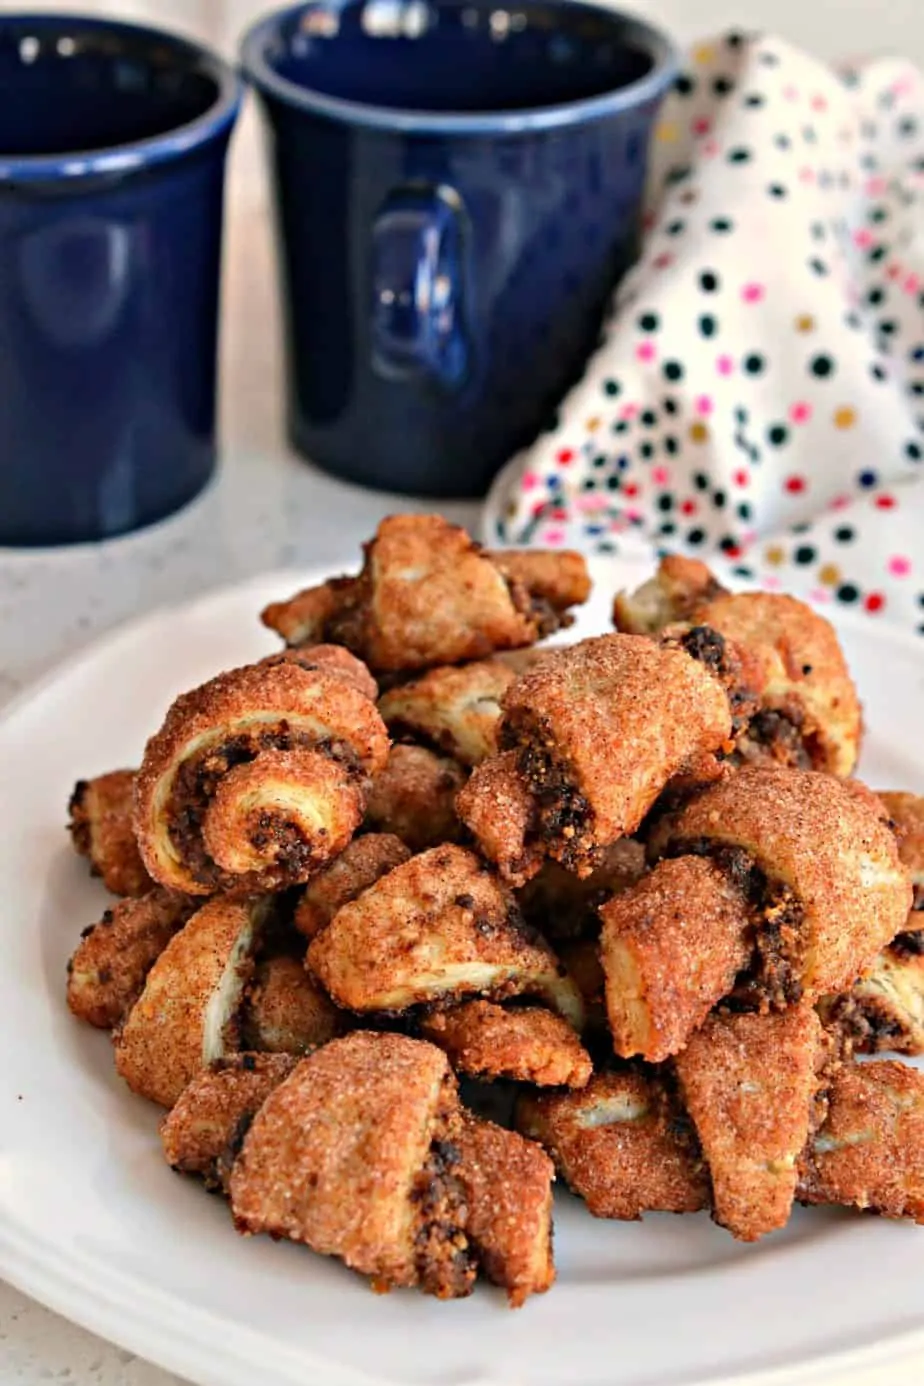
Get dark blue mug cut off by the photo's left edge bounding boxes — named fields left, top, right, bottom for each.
left=0, top=14, right=241, bottom=545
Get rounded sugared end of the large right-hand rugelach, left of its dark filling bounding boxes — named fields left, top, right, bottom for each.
left=600, top=857, right=751, bottom=1063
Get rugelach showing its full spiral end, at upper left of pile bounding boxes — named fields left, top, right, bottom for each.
left=134, top=650, right=388, bottom=895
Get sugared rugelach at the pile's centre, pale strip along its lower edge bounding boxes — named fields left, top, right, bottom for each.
left=308, top=845, right=583, bottom=1026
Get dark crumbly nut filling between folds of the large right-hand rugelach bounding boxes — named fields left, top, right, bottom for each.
left=670, top=840, right=805, bottom=1010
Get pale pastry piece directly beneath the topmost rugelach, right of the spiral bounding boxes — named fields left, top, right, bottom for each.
left=378, top=660, right=517, bottom=766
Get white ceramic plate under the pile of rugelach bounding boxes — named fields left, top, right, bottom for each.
left=0, top=554, right=924, bottom=1386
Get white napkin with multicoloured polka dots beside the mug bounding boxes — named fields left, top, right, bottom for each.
left=485, top=35, right=924, bottom=633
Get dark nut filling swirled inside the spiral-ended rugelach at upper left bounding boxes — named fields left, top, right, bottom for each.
left=168, top=722, right=357, bottom=886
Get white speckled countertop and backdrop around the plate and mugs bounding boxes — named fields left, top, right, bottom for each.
left=0, top=0, right=924, bottom=1386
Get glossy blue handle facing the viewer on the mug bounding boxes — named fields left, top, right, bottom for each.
left=371, top=186, right=470, bottom=389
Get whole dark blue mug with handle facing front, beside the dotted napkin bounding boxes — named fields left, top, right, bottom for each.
left=242, top=0, right=676, bottom=496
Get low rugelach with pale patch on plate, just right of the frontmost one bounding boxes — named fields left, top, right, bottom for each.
left=517, top=1070, right=709, bottom=1221
